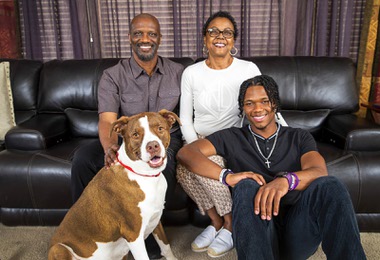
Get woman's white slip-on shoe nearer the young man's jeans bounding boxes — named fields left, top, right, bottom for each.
left=207, top=228, right=234, bottom=257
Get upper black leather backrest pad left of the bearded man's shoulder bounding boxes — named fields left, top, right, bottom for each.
left=38, top=59, right=119, bottom=113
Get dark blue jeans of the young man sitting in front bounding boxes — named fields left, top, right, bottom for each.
left=232, top=176, right=366, bottom=260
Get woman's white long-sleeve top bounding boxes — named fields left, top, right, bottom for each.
left=180, top=58, right=261, bottom=143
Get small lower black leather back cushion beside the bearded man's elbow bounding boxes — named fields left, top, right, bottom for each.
left=65, top=108, right=98, bottom=137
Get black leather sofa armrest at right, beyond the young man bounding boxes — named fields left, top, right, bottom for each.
left=323, top=114, right=380, bottom=152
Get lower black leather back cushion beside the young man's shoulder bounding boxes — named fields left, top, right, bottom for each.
left=281, top=109, right=330, bottom=135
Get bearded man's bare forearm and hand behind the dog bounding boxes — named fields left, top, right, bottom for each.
left=98, top=112, right=119, bottom=167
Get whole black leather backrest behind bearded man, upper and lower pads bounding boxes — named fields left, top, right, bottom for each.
left=38, top=58, right=194, bottom=137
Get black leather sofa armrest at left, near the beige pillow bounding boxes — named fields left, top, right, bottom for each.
left=5, top=114, right=69, bottom=151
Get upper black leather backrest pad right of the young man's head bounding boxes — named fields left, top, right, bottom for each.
left=244, top=56, right=359, bottom=114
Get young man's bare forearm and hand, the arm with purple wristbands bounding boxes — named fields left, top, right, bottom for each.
left=254, top=151, right=327, bottom=220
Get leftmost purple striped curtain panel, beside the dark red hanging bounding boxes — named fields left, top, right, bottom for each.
left=19, top=0, right=83, bottom=60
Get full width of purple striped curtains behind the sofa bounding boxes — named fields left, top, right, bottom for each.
left=20, top=0, right=365, bottom=60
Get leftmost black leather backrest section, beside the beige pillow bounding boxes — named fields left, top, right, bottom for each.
left=0, top=59, right=43, bottom=124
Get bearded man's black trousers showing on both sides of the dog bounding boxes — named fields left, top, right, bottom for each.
left=71, top=130, right=183, bottom=203
